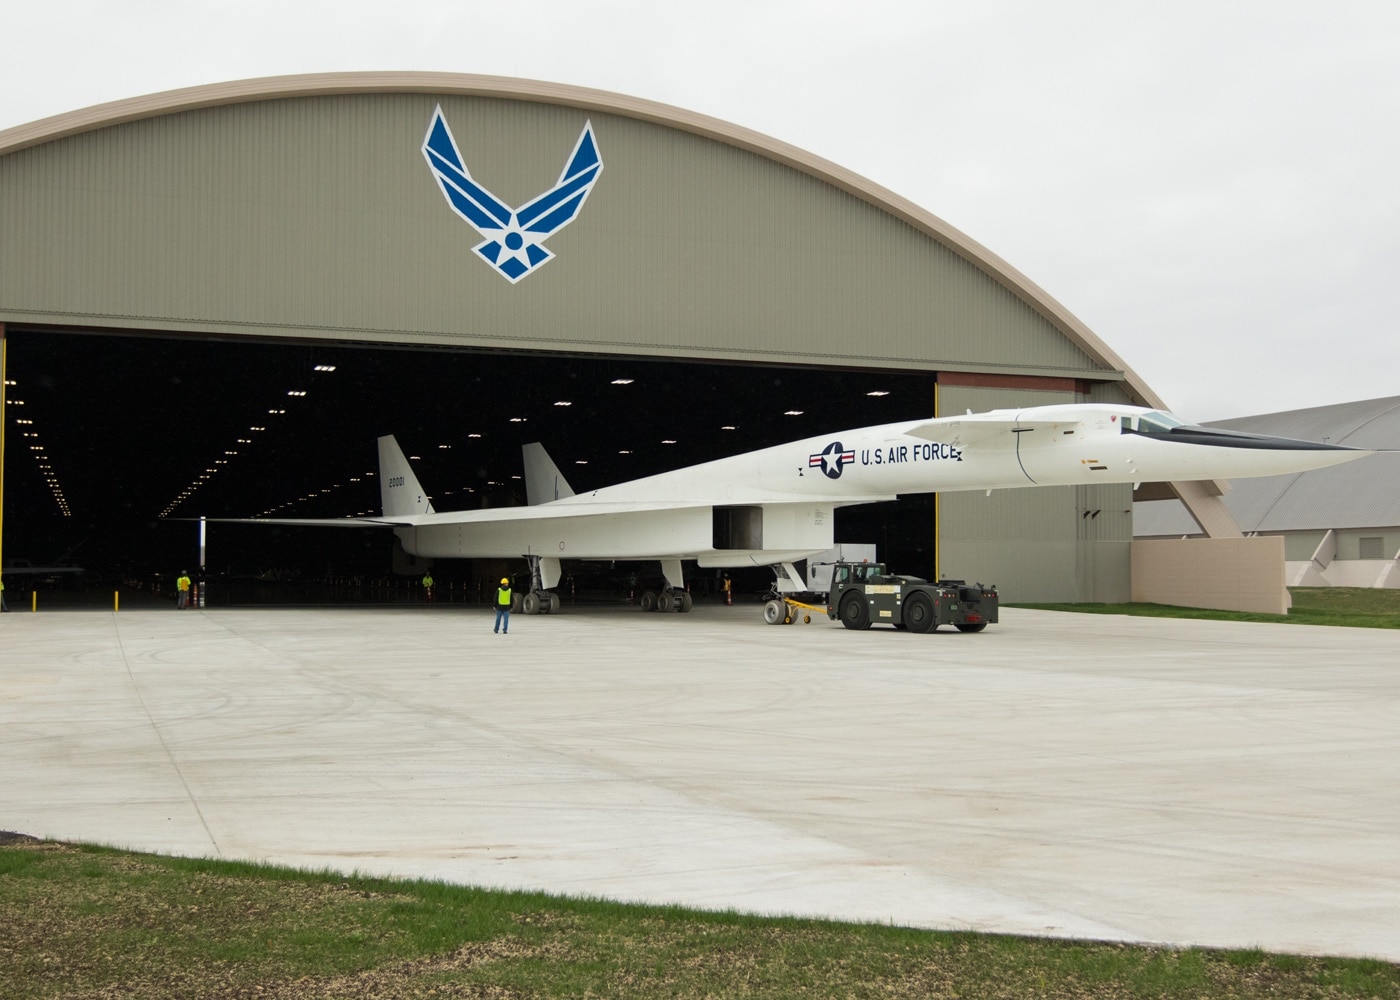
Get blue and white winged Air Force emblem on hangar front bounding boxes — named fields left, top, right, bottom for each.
left=423, top=105, right=603, bottom=284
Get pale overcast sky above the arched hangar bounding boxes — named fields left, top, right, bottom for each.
left=0, top=0, right=1400, bottom=420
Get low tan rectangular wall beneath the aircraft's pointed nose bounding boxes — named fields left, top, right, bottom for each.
left=1133, top=536, right=1291, bottom=615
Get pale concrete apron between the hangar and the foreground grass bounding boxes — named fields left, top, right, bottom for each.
left=0, top=605, right=1400, bottom=961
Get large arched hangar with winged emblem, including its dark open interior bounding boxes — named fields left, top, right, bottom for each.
left=0, top=73, right=1239, bottom=601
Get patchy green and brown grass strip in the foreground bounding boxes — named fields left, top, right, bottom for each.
left=0, top=835, right=1400, bottom=1000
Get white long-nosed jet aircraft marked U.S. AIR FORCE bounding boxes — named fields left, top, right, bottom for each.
left=253, top=403, right=1371, bottom=613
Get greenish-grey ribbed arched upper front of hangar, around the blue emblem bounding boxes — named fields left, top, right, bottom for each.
left=0, top=73, right=1162, bottom=406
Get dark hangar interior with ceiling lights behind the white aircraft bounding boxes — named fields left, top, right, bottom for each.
left=4, top=326, right=934, bottom=599
